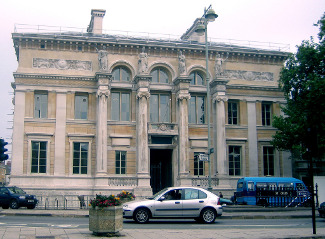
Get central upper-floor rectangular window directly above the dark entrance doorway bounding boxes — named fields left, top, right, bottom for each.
left=150, top=94, right=170, bottom=123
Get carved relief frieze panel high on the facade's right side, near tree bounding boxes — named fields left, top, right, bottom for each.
left=223, top=70, right=274, bottom=81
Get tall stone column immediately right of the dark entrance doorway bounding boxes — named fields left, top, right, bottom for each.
left=174, top=77, right=191, bottom=186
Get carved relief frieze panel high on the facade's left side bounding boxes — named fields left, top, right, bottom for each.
left=33, top=58, right=92, bottom=71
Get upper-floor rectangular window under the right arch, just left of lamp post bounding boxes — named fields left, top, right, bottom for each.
left=188, top=96, right=205, bottom=124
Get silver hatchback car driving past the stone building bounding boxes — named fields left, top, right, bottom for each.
left=123, top=187, right=222, bottom=223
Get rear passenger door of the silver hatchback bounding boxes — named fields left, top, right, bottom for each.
left=183, top=188, right=208, bottom=217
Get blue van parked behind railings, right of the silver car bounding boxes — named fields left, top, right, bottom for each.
left=234, top=177, right=310, bottom=207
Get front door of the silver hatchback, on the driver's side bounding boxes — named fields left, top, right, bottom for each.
left=153, top=189, right=183, bottom=217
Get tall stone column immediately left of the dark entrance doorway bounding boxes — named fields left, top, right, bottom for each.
left=135, top=75, right=151, bottom=191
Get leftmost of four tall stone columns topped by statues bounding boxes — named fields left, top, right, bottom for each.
left=96, top=73, right=111, bottom=176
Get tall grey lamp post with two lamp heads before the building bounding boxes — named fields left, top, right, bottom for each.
left=195, top=5, right=218, bottom=191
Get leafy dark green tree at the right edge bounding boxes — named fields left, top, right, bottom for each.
left=272, top=13, right=325, bottom=166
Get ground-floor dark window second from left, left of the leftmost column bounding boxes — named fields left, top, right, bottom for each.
left=72, top=142, right=89, bottom=174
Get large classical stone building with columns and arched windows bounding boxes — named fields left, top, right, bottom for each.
left=10, top=10, right=292, bottom=196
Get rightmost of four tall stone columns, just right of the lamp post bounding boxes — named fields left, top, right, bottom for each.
left=211, top=78, right=228, bottom=180
